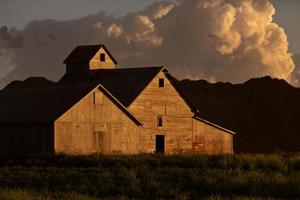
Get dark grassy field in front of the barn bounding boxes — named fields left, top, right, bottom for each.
left=0, top=154, right=300, bottom=200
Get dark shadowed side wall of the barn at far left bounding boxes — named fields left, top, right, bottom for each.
left=0, top=124, right=54, bottom=155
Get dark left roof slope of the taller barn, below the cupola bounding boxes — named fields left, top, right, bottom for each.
left=59, top=67, right=163, bottom=107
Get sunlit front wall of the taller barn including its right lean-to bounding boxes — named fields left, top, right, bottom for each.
left=129, top=72, right=232, bottom=154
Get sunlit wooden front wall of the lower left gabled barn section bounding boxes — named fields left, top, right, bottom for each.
left=55, top=89, right=139, bottom=154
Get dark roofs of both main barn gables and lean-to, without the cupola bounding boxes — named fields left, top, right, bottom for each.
left=0, top=66, right=234, bottom=134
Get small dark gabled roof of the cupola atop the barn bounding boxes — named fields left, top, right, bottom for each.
left=63, top=44, right=118, bottom=64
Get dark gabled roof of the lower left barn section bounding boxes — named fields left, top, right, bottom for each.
left=0, top=84, right=141, bottom=125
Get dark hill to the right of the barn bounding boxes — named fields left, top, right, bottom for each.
left=178, top=77, right=300, bottom=153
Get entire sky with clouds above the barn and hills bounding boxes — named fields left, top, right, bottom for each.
left=0, top=0, right=300, bottom=87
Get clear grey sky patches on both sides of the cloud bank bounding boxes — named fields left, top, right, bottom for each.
left=0, top=0, right=300, bottom=53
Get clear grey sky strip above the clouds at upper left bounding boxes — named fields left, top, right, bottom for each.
left=0, top=0, right=155, bottom=28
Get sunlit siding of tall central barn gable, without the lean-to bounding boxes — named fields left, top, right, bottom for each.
left=128, top=72, right=193, bottom=154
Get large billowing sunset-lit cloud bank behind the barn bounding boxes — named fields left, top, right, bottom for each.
left=0, top=0, right=297, bottom=87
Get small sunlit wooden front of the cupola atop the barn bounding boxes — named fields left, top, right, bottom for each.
left=89, top=48, right=116, bottom=69
